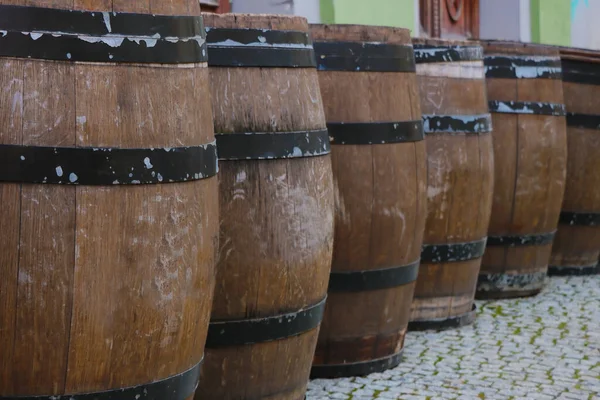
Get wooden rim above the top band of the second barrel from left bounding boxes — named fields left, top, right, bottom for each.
left=202, top=13, right=308, bottom=32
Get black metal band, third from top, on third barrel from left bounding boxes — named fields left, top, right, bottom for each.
left=329, top=260, right=420, bottom=292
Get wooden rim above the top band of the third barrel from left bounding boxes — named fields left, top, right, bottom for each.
left=310, top=24, right=410, bottom=44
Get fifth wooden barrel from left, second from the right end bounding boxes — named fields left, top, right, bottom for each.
left=477, top=41, right=567, bottom=299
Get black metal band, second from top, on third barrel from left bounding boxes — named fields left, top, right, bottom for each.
left=327, top=120, right=425, bottom=145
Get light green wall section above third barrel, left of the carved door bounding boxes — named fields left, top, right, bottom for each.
left=321, top=0, right=415, bottom=31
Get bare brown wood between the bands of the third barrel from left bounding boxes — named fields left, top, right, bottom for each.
left=312, top=25, right=426, bottom=365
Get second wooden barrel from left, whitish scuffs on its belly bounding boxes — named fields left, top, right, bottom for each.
left=197, top=14, right=333, bottom=400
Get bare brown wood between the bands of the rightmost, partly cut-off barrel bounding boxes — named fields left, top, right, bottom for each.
left=550, top=48, right=600, bottom=267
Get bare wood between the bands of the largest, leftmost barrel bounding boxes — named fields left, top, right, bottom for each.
left=0, top=0, right=218, bottom=396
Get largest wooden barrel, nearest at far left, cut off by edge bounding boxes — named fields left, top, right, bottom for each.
left=0, top=0, right=218, bottom=400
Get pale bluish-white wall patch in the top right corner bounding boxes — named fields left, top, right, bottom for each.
left=571, top=0, right=600, bottom=50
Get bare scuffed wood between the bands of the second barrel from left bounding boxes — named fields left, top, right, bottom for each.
left=197, top=14, right=333, bottom=400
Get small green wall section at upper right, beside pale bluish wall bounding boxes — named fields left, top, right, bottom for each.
left=530, top=0, right=571, bottom=46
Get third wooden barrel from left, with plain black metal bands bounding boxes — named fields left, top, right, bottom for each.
left=311, top=25, right=427, bottom=378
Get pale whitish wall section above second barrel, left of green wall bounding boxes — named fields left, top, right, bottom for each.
left=231, top=0, right=321, bottom=23
